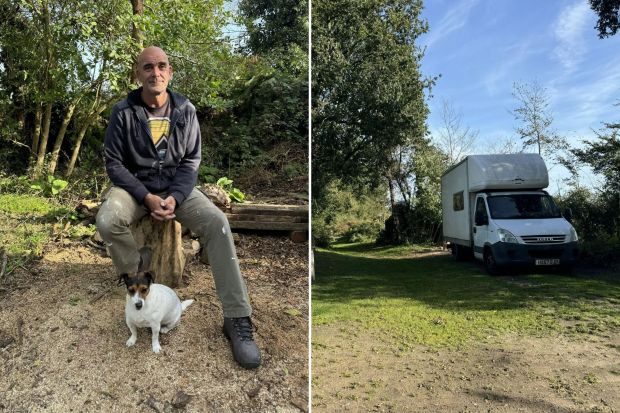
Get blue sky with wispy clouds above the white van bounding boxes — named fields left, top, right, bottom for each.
left=419, top=0, right=620, bottom=193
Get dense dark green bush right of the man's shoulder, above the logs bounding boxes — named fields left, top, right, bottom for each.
left=203, top=67, right=308, bottom=183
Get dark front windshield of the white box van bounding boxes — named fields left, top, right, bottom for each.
left=487, top=194, right=562, bottom=219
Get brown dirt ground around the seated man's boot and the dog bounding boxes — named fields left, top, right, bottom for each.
left=0, top=234, right=308, bottom=412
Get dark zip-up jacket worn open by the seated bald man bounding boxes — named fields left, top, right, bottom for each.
left=104, top=88, right=201, bottom=206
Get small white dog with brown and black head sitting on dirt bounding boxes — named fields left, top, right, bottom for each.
left=120, top=271, right=194, bottom=353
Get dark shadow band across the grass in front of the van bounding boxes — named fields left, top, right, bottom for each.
left=313, top=249, right=620, bottom=311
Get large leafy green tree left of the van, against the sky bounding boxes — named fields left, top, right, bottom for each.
left=312, top=0, right=433, bottom=197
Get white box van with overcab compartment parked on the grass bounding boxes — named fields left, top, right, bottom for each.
left=441, top=153, right=579, bottom=274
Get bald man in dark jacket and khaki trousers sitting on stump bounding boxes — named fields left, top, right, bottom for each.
left=97, top=47, right=261, bottom=369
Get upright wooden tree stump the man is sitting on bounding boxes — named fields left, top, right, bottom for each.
left=130, top=215, right=185, bottom=288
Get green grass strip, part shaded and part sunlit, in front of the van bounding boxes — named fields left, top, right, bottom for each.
left=312, top=240, right=620, bottom=347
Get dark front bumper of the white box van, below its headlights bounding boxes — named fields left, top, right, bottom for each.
left=491, top=242, right=579, bottom=266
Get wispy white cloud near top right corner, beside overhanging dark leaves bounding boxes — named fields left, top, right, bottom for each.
left=553, top=0, right=594, bottom=71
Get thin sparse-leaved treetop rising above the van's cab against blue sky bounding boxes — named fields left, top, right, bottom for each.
left=512, top=82, right=568, bottom=157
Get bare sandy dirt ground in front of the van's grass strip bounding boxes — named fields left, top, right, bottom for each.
left=312, top=318, right=620, bottom=413
